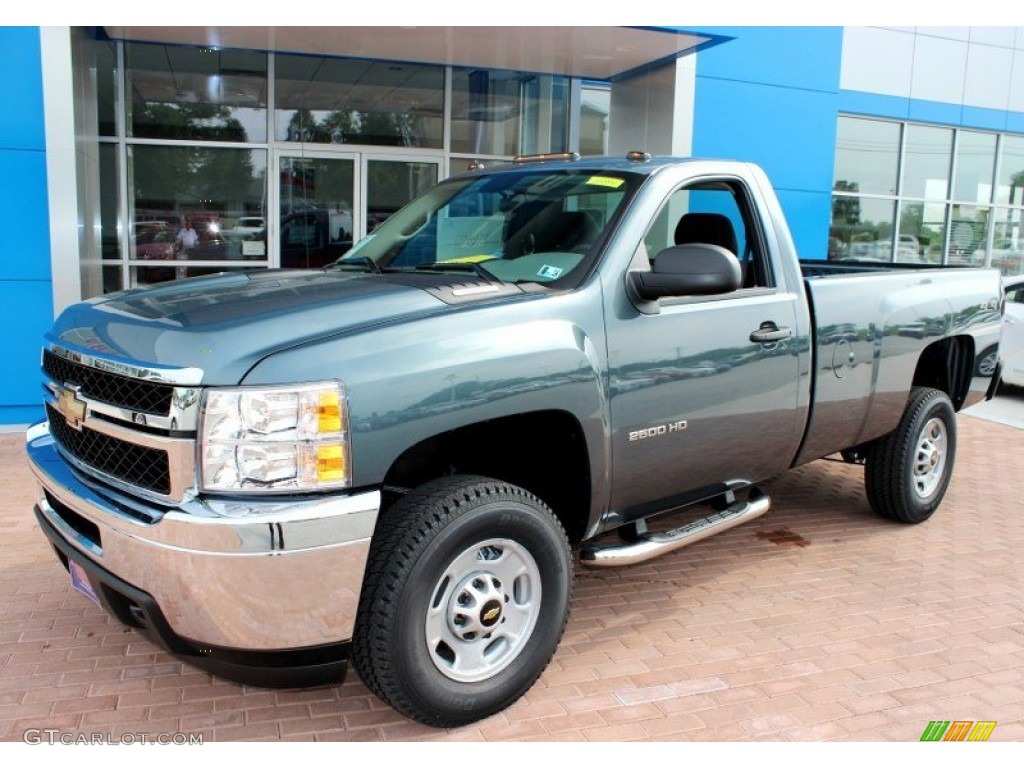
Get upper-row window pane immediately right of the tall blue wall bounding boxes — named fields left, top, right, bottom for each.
left=833, top=117, right=900, bottom=195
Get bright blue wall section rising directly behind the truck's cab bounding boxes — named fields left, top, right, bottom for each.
left=693, top=27, right=843, bottom=259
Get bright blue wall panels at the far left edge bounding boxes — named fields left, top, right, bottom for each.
left=0, top=27, right=50, bottom=425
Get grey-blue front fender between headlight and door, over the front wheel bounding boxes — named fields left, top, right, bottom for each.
left=244, top=284, right=610, bottom=536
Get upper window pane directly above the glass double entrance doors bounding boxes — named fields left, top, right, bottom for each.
left=274, top=55, right=444, bottom=148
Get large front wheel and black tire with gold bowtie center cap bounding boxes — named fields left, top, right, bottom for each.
left=352, top=475, right=572, bottom=727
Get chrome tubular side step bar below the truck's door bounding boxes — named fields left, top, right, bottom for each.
left=580, top=488, right=771, bottom=568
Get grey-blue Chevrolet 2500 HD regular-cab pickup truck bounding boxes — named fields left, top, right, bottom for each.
left=27, top=153, right=1001, bottom=727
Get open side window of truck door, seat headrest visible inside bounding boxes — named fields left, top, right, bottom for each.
left=644, top=180, right=775, bottom=288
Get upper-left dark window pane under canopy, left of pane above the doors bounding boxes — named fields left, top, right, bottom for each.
left=125, top=43, right=267, bottom=141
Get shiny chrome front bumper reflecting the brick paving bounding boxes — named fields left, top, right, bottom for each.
left=26, top=424, right=381, bottom=652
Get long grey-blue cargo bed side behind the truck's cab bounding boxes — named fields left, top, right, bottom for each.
left=796, top=261, right=1000, bottom=464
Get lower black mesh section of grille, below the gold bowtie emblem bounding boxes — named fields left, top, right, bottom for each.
left=46, top=403, right=171, bottom=496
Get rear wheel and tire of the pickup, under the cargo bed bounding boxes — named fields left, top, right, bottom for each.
left=864, top=387, right=956, bottom=523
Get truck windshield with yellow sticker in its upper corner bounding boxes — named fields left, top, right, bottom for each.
left=335, top=169, right=638, bottom=285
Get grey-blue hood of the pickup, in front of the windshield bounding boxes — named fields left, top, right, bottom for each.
left=48, top=270, right=447, bottom=384
